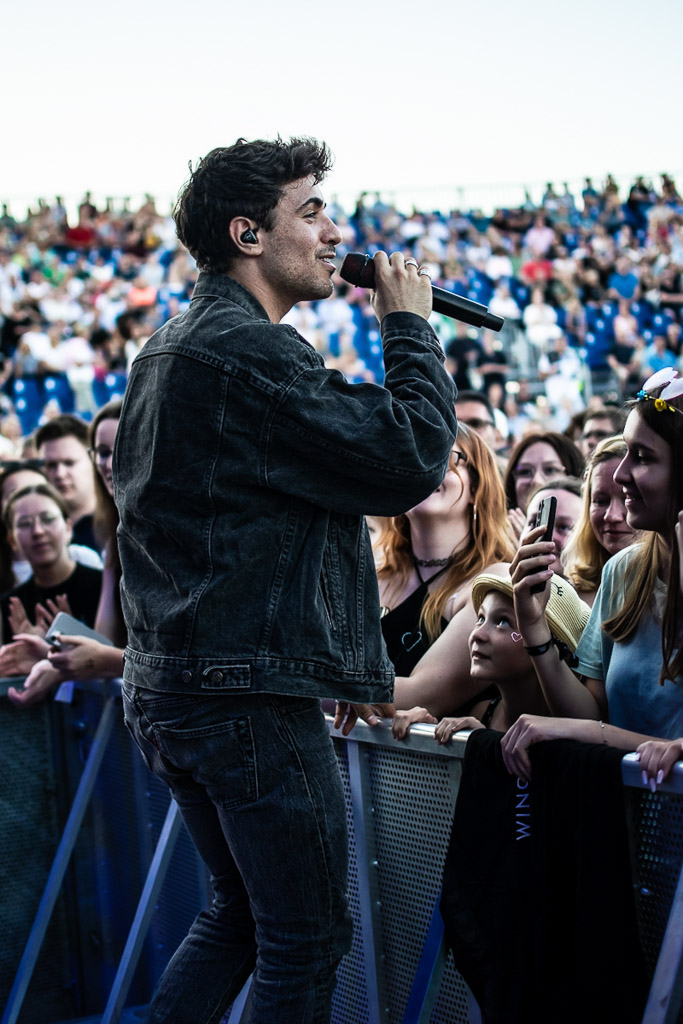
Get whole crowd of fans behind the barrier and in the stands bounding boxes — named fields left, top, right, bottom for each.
left=0, top=175, right=683, bottom=1019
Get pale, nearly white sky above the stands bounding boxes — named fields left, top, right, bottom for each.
left=5, top=0, right=683, bottom=212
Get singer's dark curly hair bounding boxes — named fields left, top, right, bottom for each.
left=173, top=137, right=332, bottom=273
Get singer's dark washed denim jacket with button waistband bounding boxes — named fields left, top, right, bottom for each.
left=114, top=273, right=457, bottom=702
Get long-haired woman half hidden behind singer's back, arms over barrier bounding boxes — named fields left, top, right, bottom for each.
left=8, top=401, right=126, bottom=705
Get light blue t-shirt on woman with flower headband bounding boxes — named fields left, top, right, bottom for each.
left=575, top=546, right=683, bottom=739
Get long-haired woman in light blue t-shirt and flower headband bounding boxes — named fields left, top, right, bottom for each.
left=503, top=368, right=683, bottom=786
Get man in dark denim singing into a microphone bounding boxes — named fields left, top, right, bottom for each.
left=114, top=139, right=456, bottom=1024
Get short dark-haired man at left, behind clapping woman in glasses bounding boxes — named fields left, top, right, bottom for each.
left=36, top=413, right=97, bottom=551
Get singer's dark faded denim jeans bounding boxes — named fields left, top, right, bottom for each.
left=123, top=684, right=351, bottom=1024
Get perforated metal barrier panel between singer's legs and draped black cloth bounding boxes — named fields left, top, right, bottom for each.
left=332, top=727, right=469, bottom=1024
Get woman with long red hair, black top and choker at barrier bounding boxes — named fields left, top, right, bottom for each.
left=375, top=425, right=514, bottom=717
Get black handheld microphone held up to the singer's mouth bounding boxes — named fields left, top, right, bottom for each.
left=339, top=253, right=505, bottom=331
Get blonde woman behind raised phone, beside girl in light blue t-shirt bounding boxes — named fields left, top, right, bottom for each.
left=562, top=437, right=638, bottom=605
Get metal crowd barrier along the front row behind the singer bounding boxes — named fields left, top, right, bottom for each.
left=0, top=681, right=683, bottom=1024
